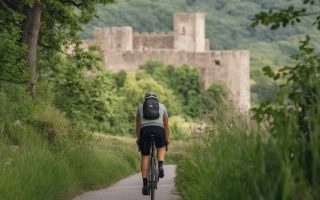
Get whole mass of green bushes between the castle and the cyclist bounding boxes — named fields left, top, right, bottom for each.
left=51, top=58, right=226, bottom=136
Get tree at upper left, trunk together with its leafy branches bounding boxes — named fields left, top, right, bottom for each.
left=0, top=0, right=114, bottom=98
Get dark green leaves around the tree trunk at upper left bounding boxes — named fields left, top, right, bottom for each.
left=0, top=0, right=114, bottom=96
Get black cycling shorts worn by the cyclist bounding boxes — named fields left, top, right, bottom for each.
left=139, top=126, right=166, bottom=156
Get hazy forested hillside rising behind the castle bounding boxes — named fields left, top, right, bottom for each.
left=81, top=0, right=320, bottom=66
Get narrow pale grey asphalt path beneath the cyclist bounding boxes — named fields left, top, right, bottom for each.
left=74, top=165, right=179, bottom=200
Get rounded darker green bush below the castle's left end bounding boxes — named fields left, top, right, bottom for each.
left=53, top=47, right=117, bottom=131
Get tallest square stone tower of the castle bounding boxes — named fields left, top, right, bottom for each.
left=173, top=13, right=205, bottom=52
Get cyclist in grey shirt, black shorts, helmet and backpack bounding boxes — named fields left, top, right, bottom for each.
left=136, top=92, right=169, bottom=195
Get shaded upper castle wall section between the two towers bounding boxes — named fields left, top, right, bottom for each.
left=133, top=32, right=174, bottom=50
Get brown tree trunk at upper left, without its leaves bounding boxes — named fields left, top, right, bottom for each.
left=22, top=0, right=41, bottom=99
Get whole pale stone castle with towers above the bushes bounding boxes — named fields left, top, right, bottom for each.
left=83, top=13, right=250, bottom=110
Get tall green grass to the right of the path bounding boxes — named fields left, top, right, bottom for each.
left=177, top=107, right=320, bottom=200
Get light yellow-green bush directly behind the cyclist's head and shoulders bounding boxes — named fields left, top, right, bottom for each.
left=112, top=71, right=181, bottom=134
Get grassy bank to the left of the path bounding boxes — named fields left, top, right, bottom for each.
left=0, top=84, right=139, bottom=200
